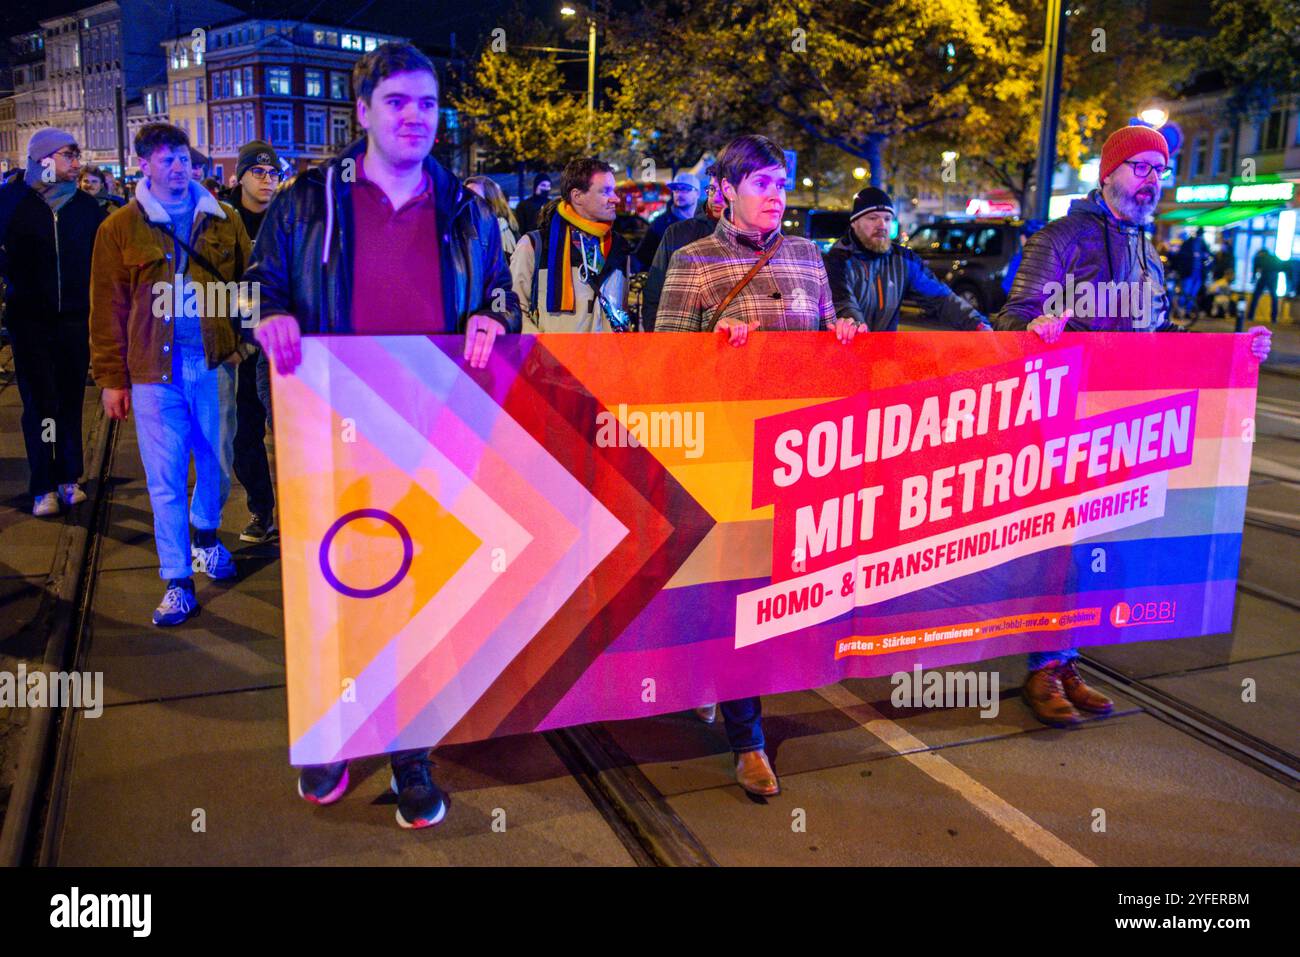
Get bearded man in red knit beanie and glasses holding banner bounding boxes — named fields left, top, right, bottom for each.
left=996, top=126, right=1270, bottom=727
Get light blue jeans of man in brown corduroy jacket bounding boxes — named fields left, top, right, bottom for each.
left=131, top=350, right=235, bottom=579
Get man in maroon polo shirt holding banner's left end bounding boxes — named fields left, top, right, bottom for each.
left=244, top=43, right=520, bottom=827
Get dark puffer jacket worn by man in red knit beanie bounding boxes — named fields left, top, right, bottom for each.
left=997, top=190, right=1177, bottom=332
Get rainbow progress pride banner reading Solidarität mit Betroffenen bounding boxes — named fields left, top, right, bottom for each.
left=274, top=333, right=1258, bottom=765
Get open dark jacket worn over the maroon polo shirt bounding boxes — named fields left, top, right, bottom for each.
left=244, top=138, right=520, bottom=334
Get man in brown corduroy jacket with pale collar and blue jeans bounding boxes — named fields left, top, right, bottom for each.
left=90, top=124, right=250, bottom=625
